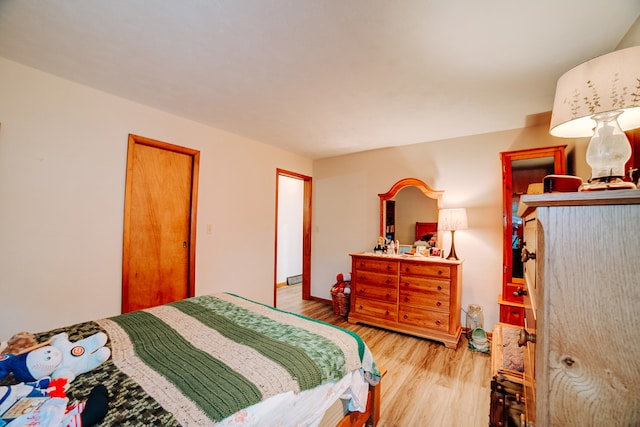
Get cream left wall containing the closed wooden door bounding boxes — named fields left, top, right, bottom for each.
left=0, top=58, right=312, bottom=339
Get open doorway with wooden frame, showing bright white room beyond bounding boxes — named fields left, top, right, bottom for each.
left=274, top=169, right=311, bottom=307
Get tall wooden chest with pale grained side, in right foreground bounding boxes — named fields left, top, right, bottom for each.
left=518, top=190, right=640, bottom=427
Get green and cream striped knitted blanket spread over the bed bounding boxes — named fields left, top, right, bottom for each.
left=87, top=294, right=379, bottom=425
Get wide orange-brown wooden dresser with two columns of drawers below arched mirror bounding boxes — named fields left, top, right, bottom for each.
left=349, top=254, right=462, bottom=348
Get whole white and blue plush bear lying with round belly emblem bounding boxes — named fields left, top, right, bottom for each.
left=0, top=332, right=111, bottom=382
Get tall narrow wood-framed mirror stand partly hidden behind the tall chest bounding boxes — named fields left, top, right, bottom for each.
left=499, top=145, right=567, bottom=326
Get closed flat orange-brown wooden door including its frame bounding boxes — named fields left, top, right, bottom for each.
left=122, top=135, right=200, bottom=313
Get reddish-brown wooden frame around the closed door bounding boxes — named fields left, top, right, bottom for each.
left=121, top=134, right=200, bottom=312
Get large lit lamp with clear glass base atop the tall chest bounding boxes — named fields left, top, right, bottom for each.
left=549, top=46, right=640, bottom=191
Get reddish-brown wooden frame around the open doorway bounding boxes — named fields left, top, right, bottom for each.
left=273, top=168, right=312, bottom=307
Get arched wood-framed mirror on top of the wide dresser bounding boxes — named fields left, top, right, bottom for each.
left=378, top=178, right=444, bottom=245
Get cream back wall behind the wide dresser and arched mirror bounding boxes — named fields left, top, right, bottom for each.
left=311, top=123, right=589, bottom=329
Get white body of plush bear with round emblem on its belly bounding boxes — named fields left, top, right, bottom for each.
left=51, top=332, right=111, bottom=382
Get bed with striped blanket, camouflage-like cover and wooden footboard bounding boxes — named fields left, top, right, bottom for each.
left=30, top=293, right=381, bottom=426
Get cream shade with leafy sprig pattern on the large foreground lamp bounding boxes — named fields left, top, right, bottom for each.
left=550, top=46, right=640, bottom=138
